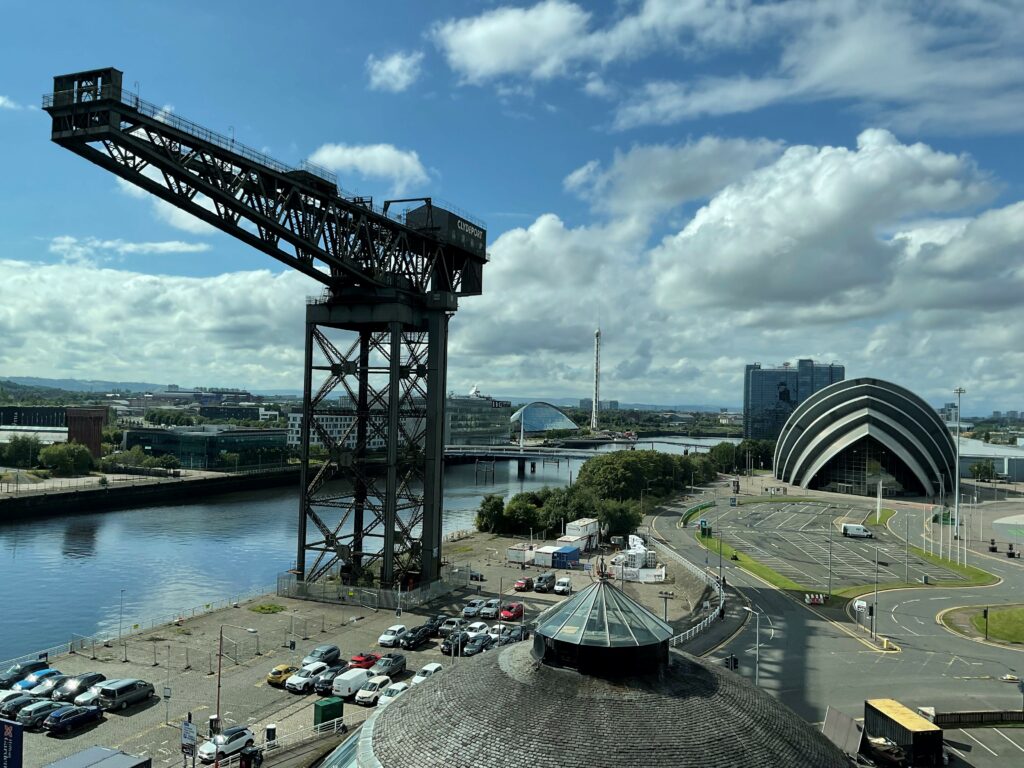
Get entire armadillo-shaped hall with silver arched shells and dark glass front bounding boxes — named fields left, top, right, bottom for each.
left=774, top=378, right=956, bottom=497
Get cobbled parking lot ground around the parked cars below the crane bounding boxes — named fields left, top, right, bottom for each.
left=14, top=573, right=577, bottom=768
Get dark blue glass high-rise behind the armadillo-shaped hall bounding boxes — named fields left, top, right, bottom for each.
left=743, top=359, right=846, bottom=440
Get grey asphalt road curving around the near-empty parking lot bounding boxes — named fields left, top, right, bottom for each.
left=653, top=500, right=1024, bottom=722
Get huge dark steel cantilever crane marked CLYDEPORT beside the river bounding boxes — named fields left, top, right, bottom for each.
left=43, top=68, right=487, bottom=587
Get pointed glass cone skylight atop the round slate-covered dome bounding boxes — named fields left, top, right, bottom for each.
left=536, top=580, right=673, bottom=647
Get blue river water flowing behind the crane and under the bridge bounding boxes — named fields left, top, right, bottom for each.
left=0, top=438, right=737, bottom=660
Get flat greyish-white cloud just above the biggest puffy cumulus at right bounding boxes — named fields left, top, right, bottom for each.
left=563, top=136, right=782, bottom=217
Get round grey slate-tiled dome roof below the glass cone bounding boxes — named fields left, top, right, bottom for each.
left=357, top=642, right=849, bottom=768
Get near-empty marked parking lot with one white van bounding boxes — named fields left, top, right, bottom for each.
left=702, top=502, right=961, bottom=591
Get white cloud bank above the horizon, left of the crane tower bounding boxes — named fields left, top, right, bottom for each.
left=0, top=260, right=316, bottom=388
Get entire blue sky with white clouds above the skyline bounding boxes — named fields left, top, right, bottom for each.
left=0, top=0, right=1024, bottom=413
